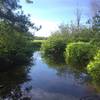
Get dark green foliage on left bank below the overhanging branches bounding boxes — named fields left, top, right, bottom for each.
left=0, top=21, right=32, bottom=66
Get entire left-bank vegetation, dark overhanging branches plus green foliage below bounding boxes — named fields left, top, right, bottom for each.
left=0, top=0, right=39, bottom=69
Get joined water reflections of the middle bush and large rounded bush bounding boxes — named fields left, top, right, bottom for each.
left=42, top=55, right=89, bottom=83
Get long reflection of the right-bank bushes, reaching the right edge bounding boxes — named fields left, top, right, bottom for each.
left=42, top=55, right=100, bottom=93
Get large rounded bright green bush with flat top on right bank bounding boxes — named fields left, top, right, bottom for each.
left=65, top=42, right=95, bottom=67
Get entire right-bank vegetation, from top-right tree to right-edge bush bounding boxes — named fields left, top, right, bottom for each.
left=41, top=11, right=100, bottom=85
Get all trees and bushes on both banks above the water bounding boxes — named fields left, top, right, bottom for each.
left=0, top=0, right=100, bottom=87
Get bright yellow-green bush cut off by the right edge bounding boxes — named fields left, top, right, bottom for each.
left=87, top=50, right=100, bottom=84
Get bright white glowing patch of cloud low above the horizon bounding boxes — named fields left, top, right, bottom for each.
left=31, top=18, right=59, bottom=37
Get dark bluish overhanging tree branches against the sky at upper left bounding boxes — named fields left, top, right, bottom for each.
left=0, top=0, right=41, bottom=32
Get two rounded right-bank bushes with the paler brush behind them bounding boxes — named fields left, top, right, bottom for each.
left=42, top=24, right=100, bottom=69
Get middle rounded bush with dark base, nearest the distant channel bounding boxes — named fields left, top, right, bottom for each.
left=41, top=34, right=66, bottom=56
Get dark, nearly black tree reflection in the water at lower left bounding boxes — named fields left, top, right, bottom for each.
left=0, top=61, right=31, bottom=100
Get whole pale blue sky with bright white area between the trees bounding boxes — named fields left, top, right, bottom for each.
left=20, top=0, right=91, bottom=37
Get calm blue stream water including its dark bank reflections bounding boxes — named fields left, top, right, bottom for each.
left=0, top=52, right=100, bottom=100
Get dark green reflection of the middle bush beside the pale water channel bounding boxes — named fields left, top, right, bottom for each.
left=42, top=54, right=67, bottom=76
